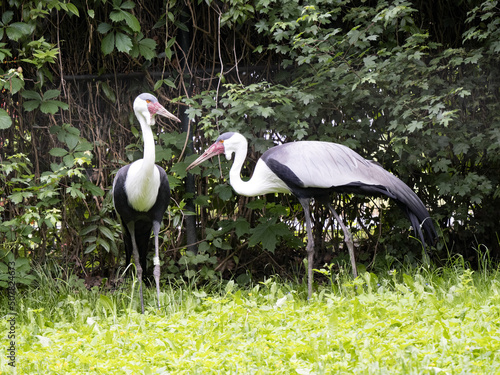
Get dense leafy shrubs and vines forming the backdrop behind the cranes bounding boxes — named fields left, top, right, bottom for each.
left=0, top=0, right=500, bottom=286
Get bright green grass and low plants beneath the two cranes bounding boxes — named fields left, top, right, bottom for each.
left=0, top=267, right=500, bottom=374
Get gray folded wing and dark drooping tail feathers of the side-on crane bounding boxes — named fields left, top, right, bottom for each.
left=261, top=141, right=437, bottom=247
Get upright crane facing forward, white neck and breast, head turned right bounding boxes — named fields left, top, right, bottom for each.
left=113, top=93, right=180, bottom=314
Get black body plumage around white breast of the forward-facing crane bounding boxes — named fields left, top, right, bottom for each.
left=113, top=164, right=170, bottom=273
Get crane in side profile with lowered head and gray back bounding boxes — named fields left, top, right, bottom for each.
left=187, top=132, right=437, bottom=298
